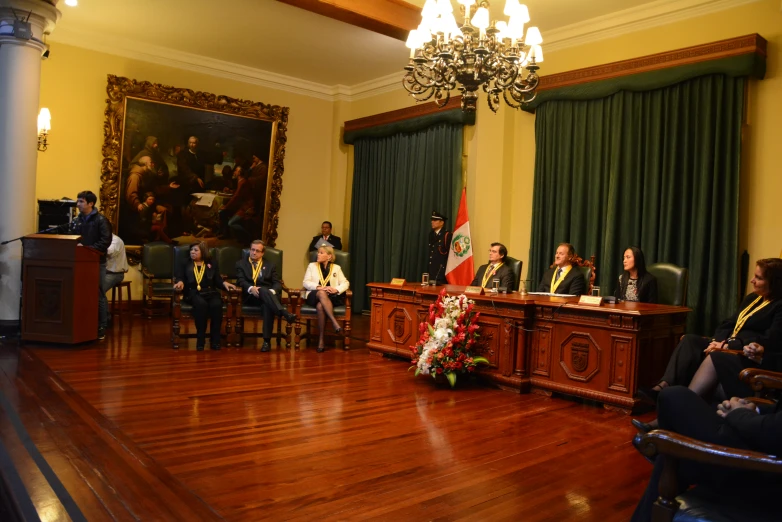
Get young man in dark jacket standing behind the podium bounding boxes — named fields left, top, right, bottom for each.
left=71, top=190, right=111, bottom=339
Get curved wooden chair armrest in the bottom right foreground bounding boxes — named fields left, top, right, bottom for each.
left=633, top=430, right=782, bottom=474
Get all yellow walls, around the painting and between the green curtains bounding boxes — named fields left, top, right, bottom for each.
left=37, top=0, right=782, bottom=295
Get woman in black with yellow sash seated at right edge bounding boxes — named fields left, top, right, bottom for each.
left=633, top=258, right=782, bottom=431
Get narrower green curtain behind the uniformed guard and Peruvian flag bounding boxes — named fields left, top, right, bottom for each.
left=350, top=124, right=462, bottom=310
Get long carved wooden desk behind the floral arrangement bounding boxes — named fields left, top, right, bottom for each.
left=367, top=283, right=689, bottom=413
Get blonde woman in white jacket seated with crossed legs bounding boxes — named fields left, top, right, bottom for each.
left=303, top=246, right=350, bottom=353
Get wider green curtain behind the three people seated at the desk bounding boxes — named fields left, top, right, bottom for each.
left=530, top=75, right=746, bottom=334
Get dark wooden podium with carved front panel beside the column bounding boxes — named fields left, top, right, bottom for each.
left=22, top=234, right=100, bottom=344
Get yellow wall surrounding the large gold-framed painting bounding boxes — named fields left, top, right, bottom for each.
left=36, top=44, right=336, bottom=299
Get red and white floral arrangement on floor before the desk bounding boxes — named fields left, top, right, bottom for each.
left=410, top=290, right=489, bottom=387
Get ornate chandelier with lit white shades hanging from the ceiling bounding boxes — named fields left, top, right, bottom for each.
left=402, top=0, right=543, bottom=112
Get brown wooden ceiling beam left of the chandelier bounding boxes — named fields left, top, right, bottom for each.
left=277, top=0, right=421, bottom=42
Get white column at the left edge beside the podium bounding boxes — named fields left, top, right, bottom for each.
left=0, top=0, right=60, bottom=327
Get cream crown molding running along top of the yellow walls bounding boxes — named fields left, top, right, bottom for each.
left=44, top=0, right=760, bottom=101
